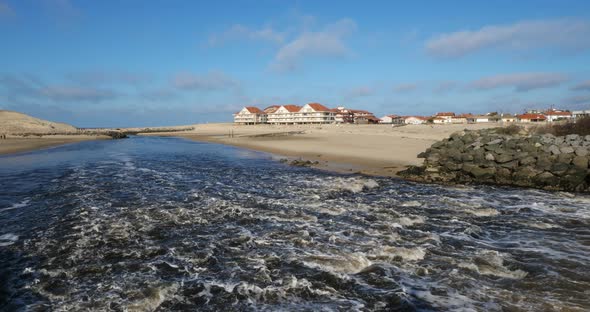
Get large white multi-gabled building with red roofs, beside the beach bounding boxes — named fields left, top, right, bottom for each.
left=234, top=103, right=379, bottom=125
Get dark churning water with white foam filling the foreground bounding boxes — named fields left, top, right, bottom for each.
left=0, top=137, right=590, bottom=311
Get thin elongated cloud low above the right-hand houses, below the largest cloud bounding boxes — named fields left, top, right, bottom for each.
left=471, top=73, right=568, bottom=92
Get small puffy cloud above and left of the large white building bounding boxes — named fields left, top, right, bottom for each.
left=172, top=71, right=240, bottom=91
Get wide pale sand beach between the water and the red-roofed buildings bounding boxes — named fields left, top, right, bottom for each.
left=149, top=123, right=500, bottom=176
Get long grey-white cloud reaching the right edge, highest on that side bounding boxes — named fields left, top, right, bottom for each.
left=426, top=19, right=590, bottom=57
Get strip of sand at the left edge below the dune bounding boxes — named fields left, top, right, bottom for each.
left=0, top=135, right=110, bottom=155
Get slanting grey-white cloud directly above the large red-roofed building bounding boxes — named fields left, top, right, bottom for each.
left=271, top=19, right=357, bottom=71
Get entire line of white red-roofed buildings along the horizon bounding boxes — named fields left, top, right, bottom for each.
left=234, top=103, right=590, bottom=125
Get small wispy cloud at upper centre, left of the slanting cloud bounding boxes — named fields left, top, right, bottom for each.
left=209, top=24, right=285, bottom=46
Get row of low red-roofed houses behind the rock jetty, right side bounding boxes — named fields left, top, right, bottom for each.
left=380, top=109, right=590, bottom=124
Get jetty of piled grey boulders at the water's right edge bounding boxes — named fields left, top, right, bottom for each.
left=400, top=128, right=590, bottom=193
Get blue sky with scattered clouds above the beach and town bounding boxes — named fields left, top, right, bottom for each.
left=0, top=0, right=590, bottom=127
